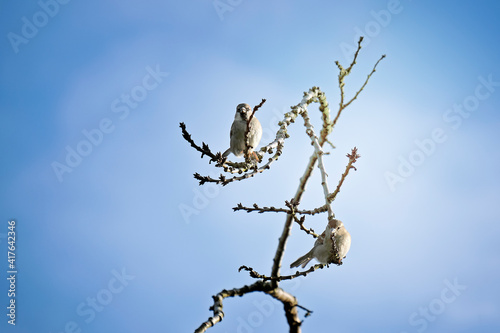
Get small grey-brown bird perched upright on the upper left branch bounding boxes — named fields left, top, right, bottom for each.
left=222, top=103, right=262, bottom=157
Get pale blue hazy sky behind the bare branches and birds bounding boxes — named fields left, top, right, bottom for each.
left=0, top=0, right=500, bottom=333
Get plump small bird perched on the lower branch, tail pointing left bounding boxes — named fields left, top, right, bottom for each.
left=290, top=219, right=351, bottom=268
